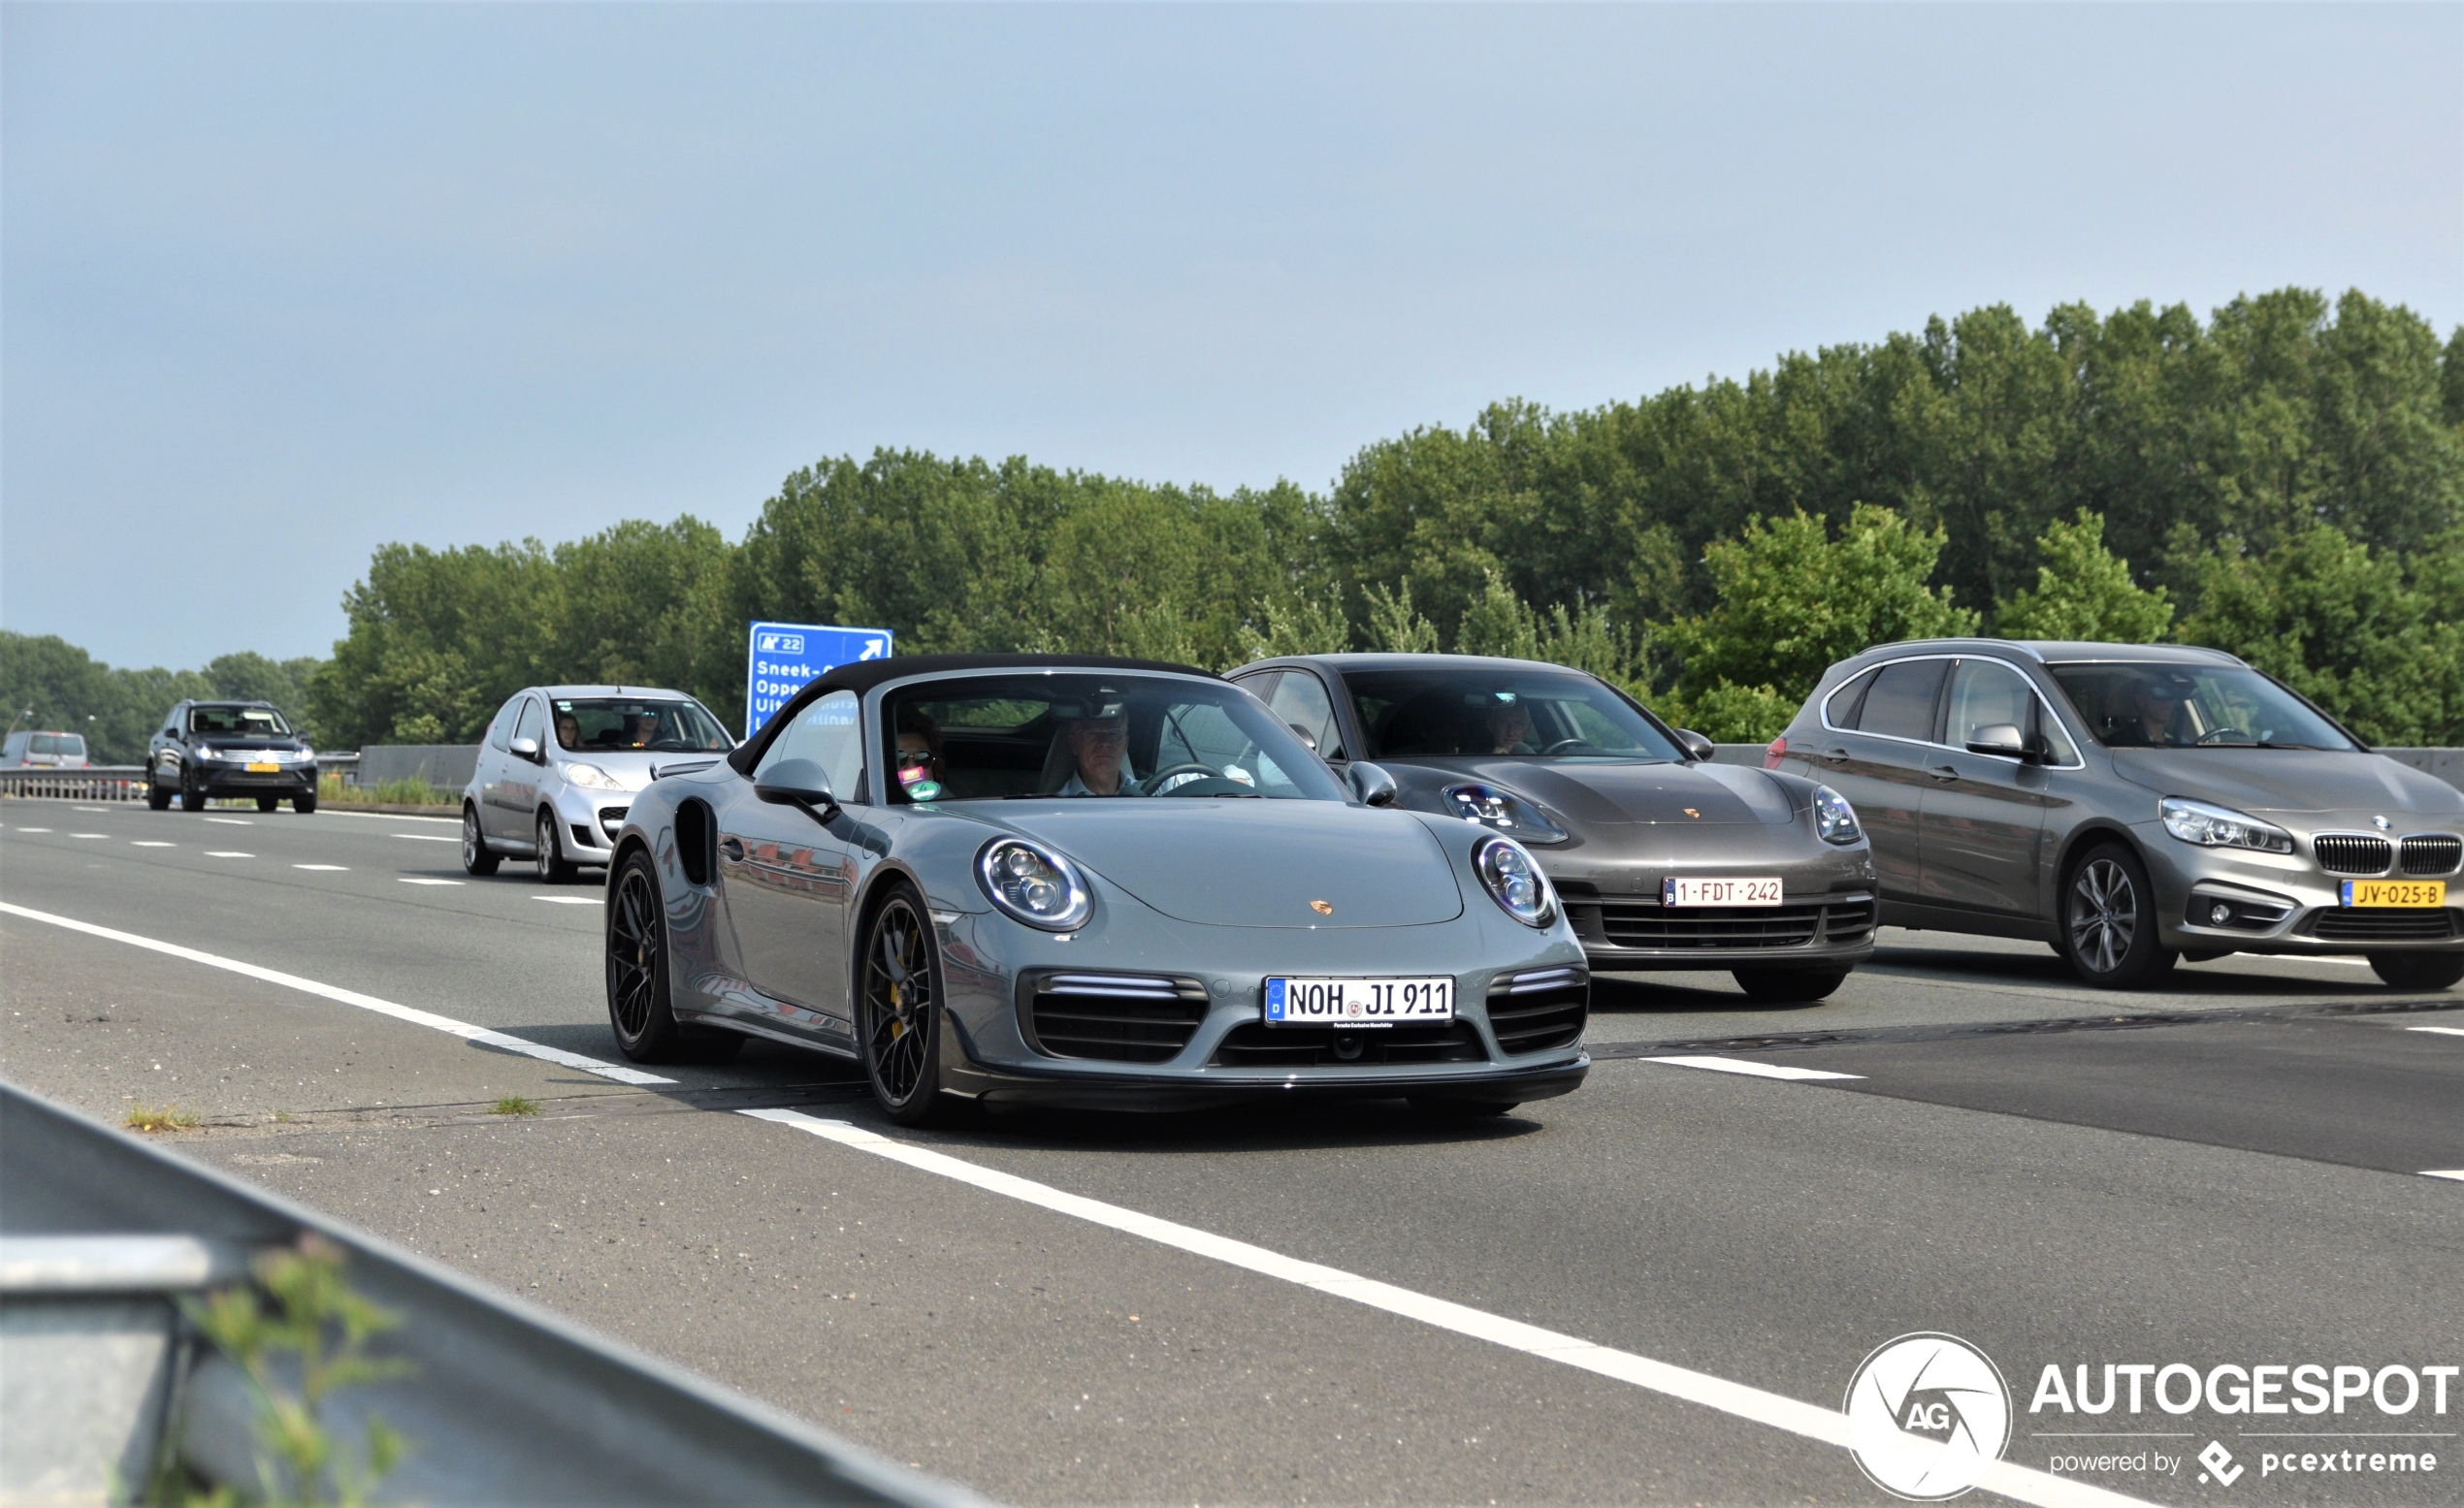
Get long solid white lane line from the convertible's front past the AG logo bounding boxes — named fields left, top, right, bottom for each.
left=736, top=1108, right=2136, bottom=1508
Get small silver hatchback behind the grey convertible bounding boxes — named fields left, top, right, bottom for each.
left=464, top=685, right=736, bottom=884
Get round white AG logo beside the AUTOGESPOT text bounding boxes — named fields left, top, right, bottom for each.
left=1848, top=1331, right=2011, bottom=1503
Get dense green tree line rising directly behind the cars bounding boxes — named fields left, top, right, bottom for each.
left=18, top=288, right=2464, bottom=747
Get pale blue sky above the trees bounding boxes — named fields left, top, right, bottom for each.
left=0, top=3, right=2464, bottom=665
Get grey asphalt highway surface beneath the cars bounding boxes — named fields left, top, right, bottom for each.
left=0, top=801, right=2464, bottom=1505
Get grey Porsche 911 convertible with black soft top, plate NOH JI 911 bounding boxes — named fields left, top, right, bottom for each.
left=606, top=656, right=1589, bottom=1124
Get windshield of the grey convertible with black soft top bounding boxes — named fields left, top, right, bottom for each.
left=882, top=670, right=1345, bottom=803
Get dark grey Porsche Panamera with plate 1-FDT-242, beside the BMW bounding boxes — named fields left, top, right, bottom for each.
left=1229, top=656, right=1875, bottom=1003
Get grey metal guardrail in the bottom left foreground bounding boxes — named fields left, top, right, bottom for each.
left=0, top=1084, right=981, bottom=1508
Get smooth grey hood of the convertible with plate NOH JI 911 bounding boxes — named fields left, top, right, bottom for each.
left=1003, top=796, right=1464, bottom=926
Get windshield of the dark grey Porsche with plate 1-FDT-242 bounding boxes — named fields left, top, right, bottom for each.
left=1345, top=665, right=1685, bottom=761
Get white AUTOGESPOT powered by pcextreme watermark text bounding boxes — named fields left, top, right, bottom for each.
left=2027, top=1363, right=2464, bottom=1489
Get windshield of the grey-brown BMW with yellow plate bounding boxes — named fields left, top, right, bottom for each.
left=2048, top=665, right=2353, bottom=749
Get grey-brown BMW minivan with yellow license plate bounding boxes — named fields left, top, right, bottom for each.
left=1765, top=638, right=2464, bottom=990
